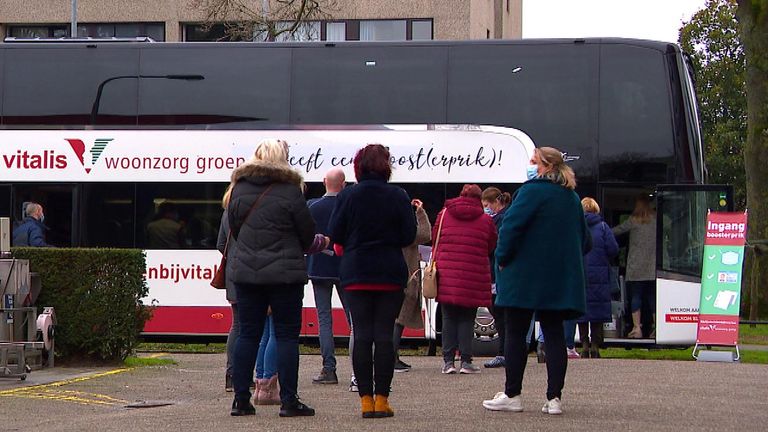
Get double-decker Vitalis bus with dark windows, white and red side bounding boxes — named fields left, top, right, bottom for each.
left=0, top=38, right=731, bottom=343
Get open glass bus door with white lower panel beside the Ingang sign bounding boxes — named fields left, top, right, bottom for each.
left=656, top=185, right=733, bottom=345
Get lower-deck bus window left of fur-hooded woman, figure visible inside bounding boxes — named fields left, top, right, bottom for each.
left=136, top=183, right=226, bottom=249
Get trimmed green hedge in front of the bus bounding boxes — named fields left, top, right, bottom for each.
left=12, top=248, right=151, bottom=362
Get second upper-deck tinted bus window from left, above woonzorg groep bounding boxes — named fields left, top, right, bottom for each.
left=139, top=46, right=291, bottom=127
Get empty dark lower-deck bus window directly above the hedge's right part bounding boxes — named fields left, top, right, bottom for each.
left=81, top=183, right=136, bottom=247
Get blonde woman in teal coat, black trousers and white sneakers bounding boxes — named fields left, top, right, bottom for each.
left=483, top=147, right=591, bottom=414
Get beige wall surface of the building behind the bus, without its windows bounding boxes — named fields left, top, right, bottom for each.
left=0, top=0, right=522, bottom=41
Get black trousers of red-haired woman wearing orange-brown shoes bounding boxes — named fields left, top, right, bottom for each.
left=346, top=290, right=404, bottom=396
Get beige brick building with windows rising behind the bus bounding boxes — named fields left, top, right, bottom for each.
left=0, top=0, right=522, bottom=42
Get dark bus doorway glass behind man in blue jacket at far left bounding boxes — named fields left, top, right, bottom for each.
left=11, top=183, right=79, bottom=247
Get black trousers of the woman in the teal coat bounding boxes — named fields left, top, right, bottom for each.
left=504, top=308, right=568, bottom=400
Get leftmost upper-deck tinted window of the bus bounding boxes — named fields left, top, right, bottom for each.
left=3, top=45, right=138, bottom=125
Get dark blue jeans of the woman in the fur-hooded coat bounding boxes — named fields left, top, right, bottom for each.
left=232, top=284, right=304, bottom=405
